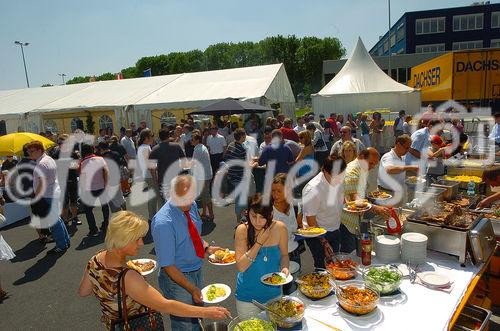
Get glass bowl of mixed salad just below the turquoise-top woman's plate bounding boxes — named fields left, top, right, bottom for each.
left=266, top=296, right=305, bottom=329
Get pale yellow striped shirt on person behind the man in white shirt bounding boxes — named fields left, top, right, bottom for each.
left=341, top=159, right=368, bottom=234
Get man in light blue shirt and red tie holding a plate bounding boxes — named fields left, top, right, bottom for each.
left=151, top=175, right=221, bottom=330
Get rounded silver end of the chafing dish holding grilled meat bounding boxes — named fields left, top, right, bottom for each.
left=469, top=218, right=497, bottom=263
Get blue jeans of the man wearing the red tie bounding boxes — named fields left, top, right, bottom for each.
left=158, top=269, right=203, bottom=331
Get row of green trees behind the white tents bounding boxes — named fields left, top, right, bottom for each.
left=67, top=35, right=345, bottom=99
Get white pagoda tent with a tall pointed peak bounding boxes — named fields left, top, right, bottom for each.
left=312, top=38, right=420, bottom=116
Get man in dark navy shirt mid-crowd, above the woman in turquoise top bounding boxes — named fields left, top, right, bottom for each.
left=259, top=129, right=295, bottom=174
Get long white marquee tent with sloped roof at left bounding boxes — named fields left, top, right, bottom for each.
left=0, top=64, right=295, bottom=132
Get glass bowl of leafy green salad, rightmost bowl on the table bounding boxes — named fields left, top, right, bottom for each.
left=363, top=265, right=403, bottom=295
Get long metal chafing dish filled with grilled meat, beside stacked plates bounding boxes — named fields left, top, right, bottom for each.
left=404, top=204, right=496, bottom=264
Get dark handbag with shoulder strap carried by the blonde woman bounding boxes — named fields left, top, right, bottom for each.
left=111, top=268, right=165, bottom=331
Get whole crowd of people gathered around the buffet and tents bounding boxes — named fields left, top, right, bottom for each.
left=0, top=108, right=484, bottom=330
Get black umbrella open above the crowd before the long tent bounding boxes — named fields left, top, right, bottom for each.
left=190, top=98, right=274, bottom=116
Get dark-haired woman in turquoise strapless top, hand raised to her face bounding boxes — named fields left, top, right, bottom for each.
left=234, top=193, right=289, bottom=315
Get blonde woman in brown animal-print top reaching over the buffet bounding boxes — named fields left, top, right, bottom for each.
left=78, top=211, right=229, bottom=330
